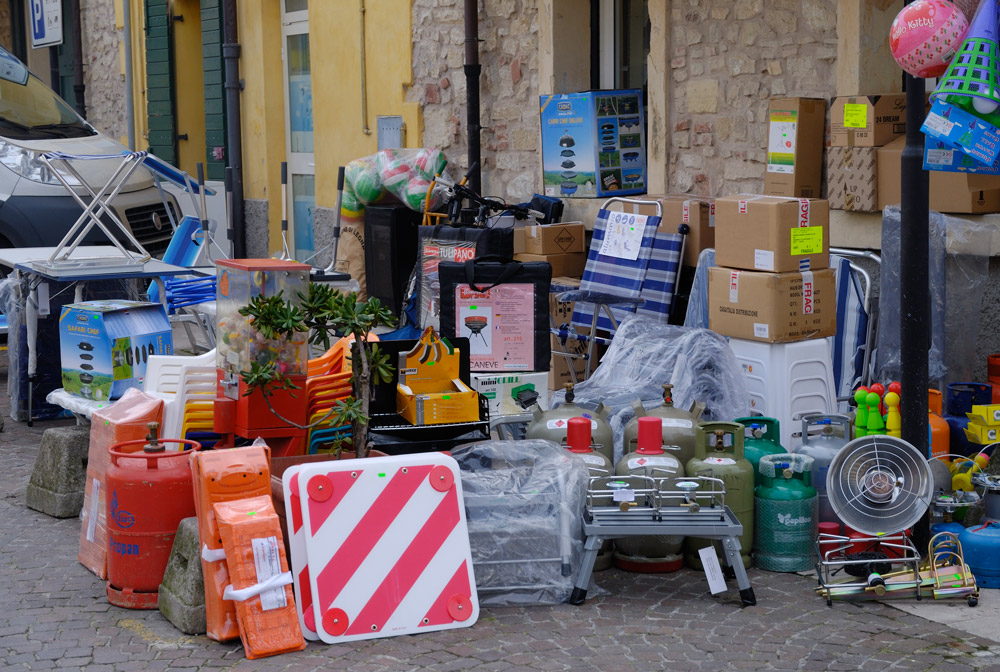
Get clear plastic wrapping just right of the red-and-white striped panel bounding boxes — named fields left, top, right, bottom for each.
left=452, top=439, right=590, bottom=606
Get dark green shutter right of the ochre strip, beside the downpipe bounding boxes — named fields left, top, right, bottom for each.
left=201, top=0, right=229, bottom=180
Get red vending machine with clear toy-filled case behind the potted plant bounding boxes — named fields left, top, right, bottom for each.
left=216, top=259, right=310, bottom=438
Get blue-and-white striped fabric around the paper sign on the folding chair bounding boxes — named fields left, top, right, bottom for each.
left=570, top=209, right=660, bottom=331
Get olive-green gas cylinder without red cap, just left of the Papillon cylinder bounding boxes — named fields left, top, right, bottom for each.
left=684, top=422, right=753, bottom=569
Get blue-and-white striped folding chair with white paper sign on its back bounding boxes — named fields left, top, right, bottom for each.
left=552, top=198, right=687, bottom=382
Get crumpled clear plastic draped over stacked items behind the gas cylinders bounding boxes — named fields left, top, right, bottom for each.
left=552, top=315, right=749, bottom=462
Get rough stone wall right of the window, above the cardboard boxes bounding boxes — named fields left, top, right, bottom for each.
left=668, top=0, right=837, bottom=196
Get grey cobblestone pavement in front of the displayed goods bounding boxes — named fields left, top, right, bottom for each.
left=0, top=359, right=1000, bottom=672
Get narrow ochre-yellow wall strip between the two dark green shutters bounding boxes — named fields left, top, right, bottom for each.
left=173, top=0, right=205, bottom=175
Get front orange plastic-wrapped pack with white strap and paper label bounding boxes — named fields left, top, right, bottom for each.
left=214, top=494, right=306, bottom=659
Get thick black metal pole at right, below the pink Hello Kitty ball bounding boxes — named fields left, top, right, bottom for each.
left=904, top=64, right=931, bottom=549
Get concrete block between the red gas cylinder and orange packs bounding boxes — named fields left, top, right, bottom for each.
left=159, top=517, right=206, bottom=635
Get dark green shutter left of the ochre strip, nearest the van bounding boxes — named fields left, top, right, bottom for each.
left=145, top=0, right=177, bottom=165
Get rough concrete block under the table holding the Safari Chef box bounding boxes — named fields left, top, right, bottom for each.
left=27, top=427, right=90, bottom=518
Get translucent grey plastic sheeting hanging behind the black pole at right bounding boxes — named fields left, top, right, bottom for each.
left=874, top=206, right=993, bottom=384
